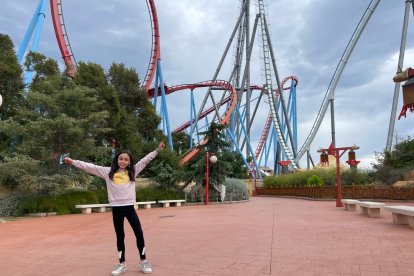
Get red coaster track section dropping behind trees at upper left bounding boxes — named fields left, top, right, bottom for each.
left=50, top=0, right=76, bottom=78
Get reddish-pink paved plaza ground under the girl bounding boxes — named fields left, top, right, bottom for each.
left=0, top=197, right=414, bottom=276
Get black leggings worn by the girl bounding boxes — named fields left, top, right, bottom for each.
left=112, top=205, right=146, bottom=263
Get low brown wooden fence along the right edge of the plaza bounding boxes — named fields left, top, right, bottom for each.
left=257, top=185, right=414, bottom=200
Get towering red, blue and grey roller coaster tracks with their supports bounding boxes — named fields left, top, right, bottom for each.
left=18, top=0, right=411, bottom=178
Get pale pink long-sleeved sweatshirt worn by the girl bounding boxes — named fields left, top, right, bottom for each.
left=72, top=150, right=158, bottom=206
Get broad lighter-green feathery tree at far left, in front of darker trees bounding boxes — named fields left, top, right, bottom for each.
left=0, top=53, right=110, bottom=194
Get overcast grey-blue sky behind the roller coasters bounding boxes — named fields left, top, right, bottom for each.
left=0, top=0, right=414, bottom=168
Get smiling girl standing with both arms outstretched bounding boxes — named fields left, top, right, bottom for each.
left=64, top=142, right=165, bottom=276
